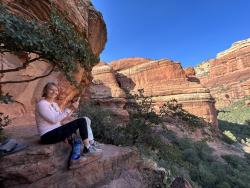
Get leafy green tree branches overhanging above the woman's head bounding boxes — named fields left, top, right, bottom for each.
left=0, top=4, right=99, bottom=84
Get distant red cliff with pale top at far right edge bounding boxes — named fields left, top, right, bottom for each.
left=195, top=39, right=250, bottom=108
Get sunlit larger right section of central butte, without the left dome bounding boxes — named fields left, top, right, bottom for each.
left=106, top=58, right=217, bottom=125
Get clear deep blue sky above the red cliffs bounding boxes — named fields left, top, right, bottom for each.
left=92, top=0, right=250, bottom=67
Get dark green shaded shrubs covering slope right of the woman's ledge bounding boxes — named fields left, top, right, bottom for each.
left=79, top=92, right=250, bottom=188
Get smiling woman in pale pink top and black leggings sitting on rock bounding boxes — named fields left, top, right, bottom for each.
left=35, top=82, right=101, bottom=154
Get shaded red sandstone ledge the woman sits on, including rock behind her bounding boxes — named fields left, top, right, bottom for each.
left=0, top=122, right=164, bottom=188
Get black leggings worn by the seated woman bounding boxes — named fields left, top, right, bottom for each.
left=41, top=118, right=88, bottom=144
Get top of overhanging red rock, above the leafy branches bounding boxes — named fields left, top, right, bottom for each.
left=1, top=0, right=107, bottom=55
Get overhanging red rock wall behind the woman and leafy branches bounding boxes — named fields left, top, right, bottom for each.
left=0, top=0, right=107, bottom=118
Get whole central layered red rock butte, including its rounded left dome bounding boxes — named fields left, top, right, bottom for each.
left=89, top=58, right=217, bottom=125
